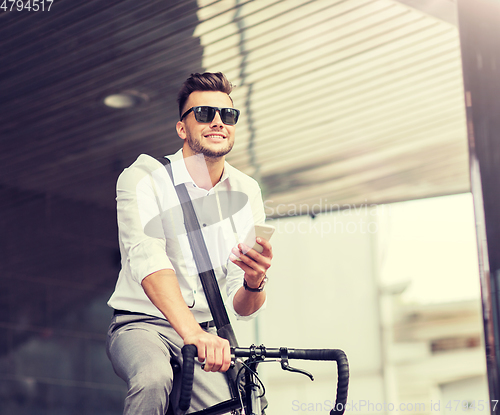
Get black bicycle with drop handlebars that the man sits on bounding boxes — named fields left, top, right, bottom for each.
left=179, top=344, right=349, bottom=415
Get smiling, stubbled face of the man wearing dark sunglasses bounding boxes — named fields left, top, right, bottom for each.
left=177, top=91, right=235, bottom=158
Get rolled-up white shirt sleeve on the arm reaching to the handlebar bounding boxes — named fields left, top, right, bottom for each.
left=116, top=161, right=174, bottom=284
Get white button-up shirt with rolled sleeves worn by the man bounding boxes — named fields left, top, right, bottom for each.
left=108, top=149, right=265, bottom=322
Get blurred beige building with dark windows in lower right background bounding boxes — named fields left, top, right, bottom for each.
left=383, top=298, right=489, bottom=414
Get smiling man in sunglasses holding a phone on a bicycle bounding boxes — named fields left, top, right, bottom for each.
left=107, top=73, right=272, bottom=415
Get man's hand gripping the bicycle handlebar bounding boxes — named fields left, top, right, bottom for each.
left=184, top=328, right=231, bottom=372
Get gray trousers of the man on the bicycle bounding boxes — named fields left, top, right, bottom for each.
left=106, top=314, right=231, bottom=415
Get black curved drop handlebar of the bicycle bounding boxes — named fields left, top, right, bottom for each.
left=179, top=344, right=349, bottom=415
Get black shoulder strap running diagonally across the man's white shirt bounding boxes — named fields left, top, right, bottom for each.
left=160, top=157, right=238, bottom=347
